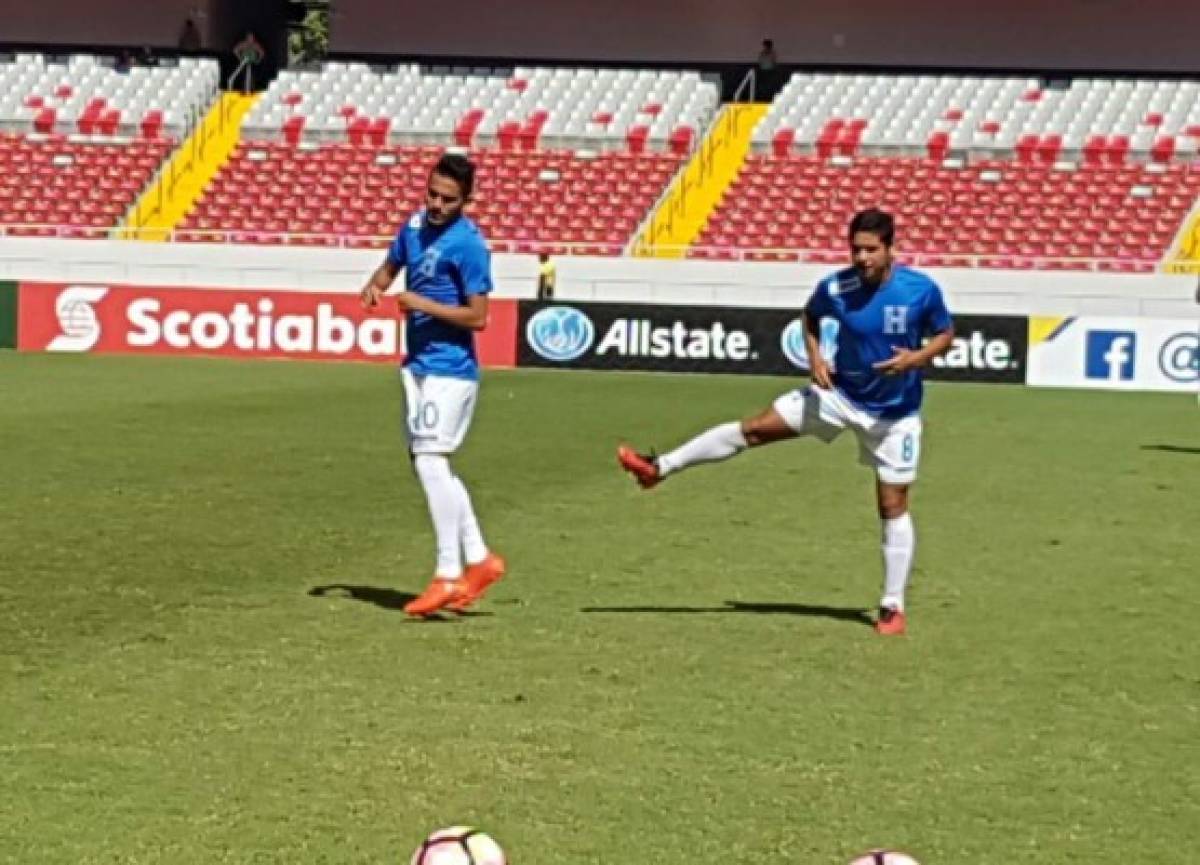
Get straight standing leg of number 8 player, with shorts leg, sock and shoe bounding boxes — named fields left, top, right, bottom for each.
left=859, top=416, right=922, bottom=635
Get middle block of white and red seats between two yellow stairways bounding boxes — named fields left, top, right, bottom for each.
left=178, top=64, right=719, bottom=254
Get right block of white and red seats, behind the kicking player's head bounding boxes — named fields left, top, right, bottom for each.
left=690, top=74, right=1200, bottom=271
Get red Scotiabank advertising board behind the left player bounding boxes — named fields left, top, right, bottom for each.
left=17, top=282, right=516, bottom=366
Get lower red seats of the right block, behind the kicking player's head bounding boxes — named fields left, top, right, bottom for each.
left=698, top=151, right=1200, bottom=271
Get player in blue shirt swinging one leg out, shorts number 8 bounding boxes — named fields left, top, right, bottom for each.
left=617, top=210, right=954, bottom=635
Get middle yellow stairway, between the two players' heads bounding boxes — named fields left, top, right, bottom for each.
left=634, top=104, right=769, bottom=258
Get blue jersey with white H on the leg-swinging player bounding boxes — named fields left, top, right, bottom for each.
left=805, top=264, right=953, bottom=419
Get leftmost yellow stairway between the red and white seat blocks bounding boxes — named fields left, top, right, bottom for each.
left=118, top=94, right=258, bottom=241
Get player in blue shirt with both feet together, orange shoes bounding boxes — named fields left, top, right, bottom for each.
left=361, top=154, right=505, bottom=615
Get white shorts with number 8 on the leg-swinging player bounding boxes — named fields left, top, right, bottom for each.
left=774, top=386, right=922, bottom=483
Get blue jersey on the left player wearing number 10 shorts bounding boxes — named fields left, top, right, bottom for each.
left=388, top=210, right=492, bottom=379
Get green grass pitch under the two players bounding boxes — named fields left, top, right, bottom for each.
left=0, top=353, right=1200, bottom=865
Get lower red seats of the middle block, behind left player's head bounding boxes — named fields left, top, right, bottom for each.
left=176, top=142, right=683, bottom=256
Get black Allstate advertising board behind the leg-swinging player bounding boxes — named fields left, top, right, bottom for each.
left=517, top=301, right=1027, bottom=382
